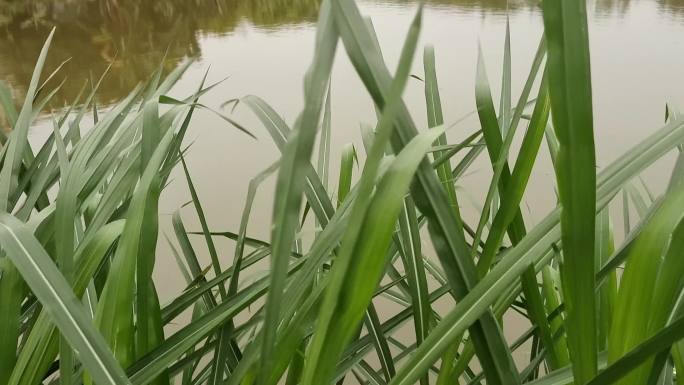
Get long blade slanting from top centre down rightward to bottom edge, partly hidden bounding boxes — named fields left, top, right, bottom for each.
left=334, top=0, right=518, bottom=384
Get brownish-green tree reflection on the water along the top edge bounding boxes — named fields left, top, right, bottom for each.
left=0, top=0, right=684, bottom=105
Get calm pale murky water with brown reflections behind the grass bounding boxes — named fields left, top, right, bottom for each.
left=0, top=0, right=684, bottom=306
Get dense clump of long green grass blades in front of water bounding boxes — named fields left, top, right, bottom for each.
left=0, top=0, right=684, bottom=385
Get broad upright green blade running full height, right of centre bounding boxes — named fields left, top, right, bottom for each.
left=543, top=0, right=597, bottom=378
